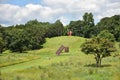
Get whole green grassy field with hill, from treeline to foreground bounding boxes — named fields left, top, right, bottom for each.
left=0, top=36, right=120, bottom=80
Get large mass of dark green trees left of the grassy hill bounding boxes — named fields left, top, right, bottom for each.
left=0, top=20, right=64, bottom=53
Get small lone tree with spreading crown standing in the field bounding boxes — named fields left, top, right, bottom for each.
left=82, top=37, right=116, bottom=67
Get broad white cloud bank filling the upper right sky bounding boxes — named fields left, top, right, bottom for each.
left=43, top=0, right=120, bottom=21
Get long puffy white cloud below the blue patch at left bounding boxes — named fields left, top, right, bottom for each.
left=0, top=4, right=63, bottom=24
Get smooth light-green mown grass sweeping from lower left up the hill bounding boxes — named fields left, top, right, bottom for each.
left=0, top=36, right=85, bottom=73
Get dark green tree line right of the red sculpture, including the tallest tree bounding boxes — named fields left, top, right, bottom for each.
left=68, top=13, right=120, bottom=41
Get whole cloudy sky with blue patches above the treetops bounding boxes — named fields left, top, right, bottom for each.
left=0, top=0, right=120, bottom=26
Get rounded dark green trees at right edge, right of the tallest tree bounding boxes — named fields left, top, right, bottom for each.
left=96, top=15, right=120, bottom=41
